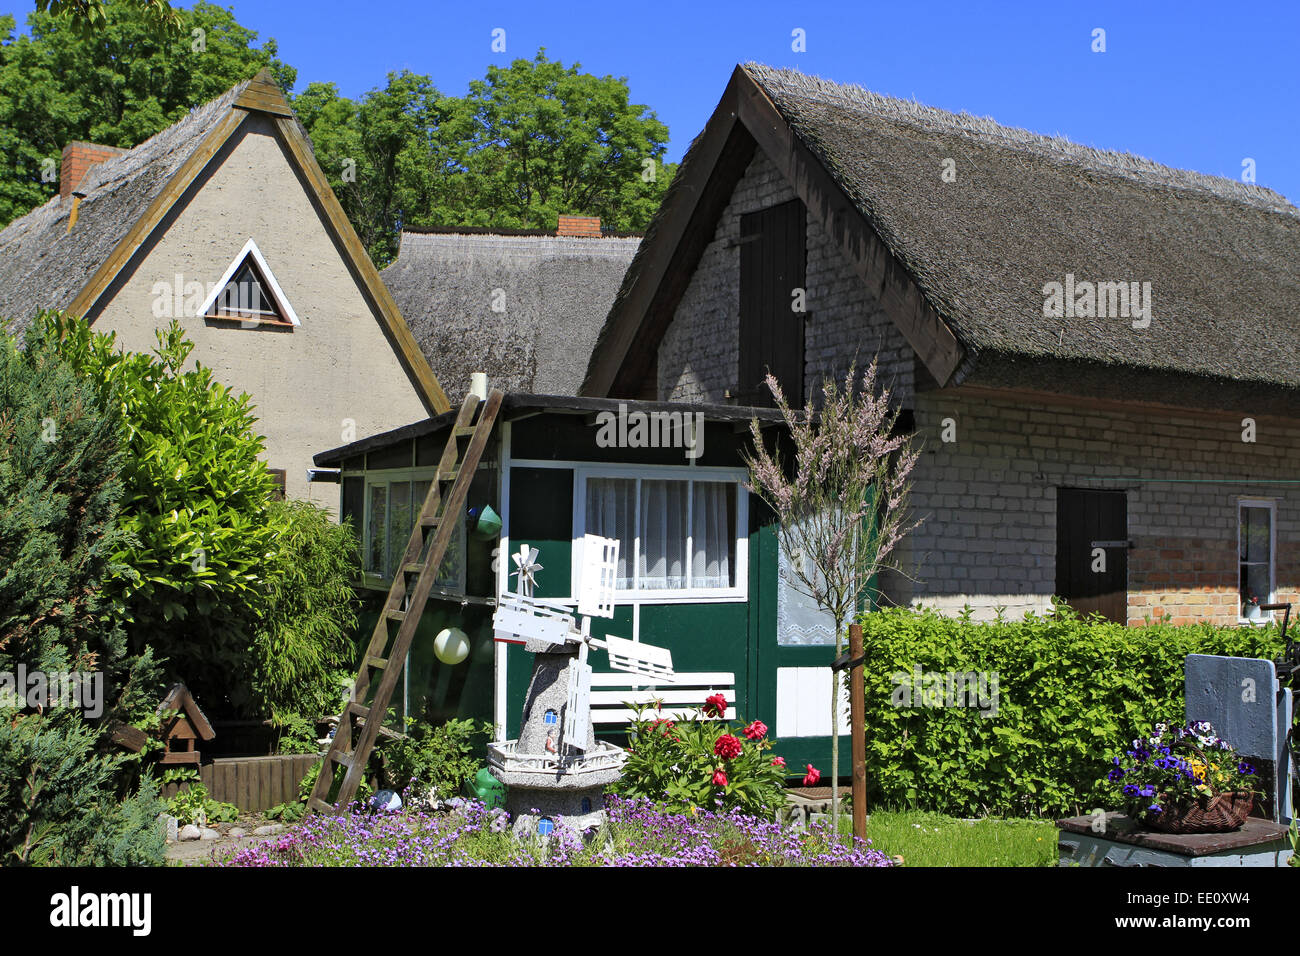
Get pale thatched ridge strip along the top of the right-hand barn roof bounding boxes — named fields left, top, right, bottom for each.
left=744, top=61, right=1300, bottom=217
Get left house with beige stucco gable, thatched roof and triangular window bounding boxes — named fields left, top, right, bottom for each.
left=0, top=70, right=449, bottom=503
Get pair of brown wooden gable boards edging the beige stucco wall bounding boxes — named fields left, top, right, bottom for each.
left=66, top=70, right=451, bottom=414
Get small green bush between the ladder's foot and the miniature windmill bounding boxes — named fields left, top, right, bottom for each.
left=384, top=717, right=491, bottom=800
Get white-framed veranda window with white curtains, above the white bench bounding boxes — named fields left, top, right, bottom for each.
left=580, top=475, right=744, bottom=597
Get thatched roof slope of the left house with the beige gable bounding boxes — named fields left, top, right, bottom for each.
left=0, top=82, right=248, bottom=329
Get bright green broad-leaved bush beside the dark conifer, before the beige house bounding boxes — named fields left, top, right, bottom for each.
left=47, top=313, right=276, bottom=711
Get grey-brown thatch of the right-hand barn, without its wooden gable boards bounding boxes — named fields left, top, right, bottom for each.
left=593, top=64, right=1300, bottom=400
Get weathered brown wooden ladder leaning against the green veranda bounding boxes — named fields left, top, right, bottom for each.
left=307, top=389, right=503, bottom=814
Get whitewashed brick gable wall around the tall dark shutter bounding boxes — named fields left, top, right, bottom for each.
left=658, top=151, right=914, bottom=405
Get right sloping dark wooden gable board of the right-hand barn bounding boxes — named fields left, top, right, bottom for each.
left=732, top=68, right=963, bottom=384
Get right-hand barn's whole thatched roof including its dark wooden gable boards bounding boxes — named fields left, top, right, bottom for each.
left=586, top=64, right=1300, bottom=411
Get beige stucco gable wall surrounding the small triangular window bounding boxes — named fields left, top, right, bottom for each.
left=87, top=116, right=426, bottom=511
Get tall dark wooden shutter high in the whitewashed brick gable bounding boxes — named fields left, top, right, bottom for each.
left=736, top=199, right=807, bottom=407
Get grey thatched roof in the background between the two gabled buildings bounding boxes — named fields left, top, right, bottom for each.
left=381, top=232, right=640, bottom=395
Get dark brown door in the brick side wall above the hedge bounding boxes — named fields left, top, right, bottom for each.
left=1056, top=488, right=1128, bottom=624
